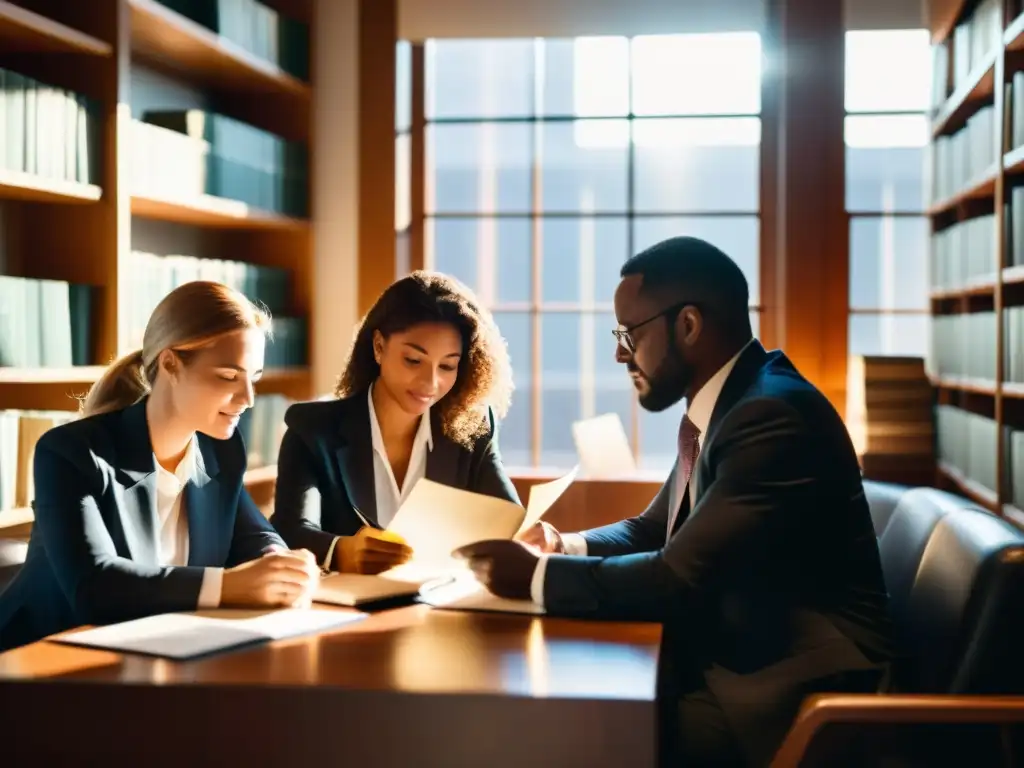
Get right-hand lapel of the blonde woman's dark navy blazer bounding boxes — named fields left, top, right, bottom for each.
left=183, top=434, right=225, bottom=566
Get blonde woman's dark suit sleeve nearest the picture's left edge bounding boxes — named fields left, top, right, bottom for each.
left=34, top=438, right=205, bottom=624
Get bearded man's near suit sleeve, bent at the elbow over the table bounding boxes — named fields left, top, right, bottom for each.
left=545, top=398, right=818, bottom=621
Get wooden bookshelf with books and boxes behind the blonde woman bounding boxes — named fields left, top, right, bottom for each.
left=0, top=0, right=313, bottom=524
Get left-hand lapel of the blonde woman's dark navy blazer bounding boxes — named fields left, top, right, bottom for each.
left=115, top=398, right=159, bottom=565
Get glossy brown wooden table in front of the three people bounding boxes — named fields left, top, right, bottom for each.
left=0, top=606, right=660, bottom=768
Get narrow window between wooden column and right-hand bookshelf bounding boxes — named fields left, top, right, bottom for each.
left=846, top=30, right=931, bottom=356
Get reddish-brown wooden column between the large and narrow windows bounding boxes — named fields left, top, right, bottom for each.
left=761, top=0, right=850, bottom=413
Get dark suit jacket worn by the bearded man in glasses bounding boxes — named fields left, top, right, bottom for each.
left=545, top=342, right=891, bottom=765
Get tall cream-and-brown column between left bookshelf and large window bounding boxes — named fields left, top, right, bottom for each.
left=310, top=0, right=397, bottom=395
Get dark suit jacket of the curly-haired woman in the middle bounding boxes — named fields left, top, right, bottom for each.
left=270, top=392, right=519, bottom=564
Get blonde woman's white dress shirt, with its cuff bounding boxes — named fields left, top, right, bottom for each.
left=153, top=436, right=224, bottom=608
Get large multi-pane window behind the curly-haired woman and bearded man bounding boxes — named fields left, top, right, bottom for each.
left=425, top=33, right=762, bottom=470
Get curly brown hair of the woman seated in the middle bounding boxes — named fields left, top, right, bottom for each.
left=335, top=270, right=512, bottom=447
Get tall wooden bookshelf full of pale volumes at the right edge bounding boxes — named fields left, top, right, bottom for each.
left=929, top=0, right=1024, bottom=525
